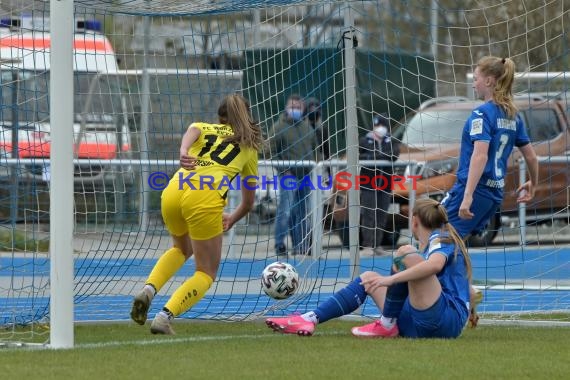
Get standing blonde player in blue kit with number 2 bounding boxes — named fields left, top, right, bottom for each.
left=442, top=57, right=538, bottom=327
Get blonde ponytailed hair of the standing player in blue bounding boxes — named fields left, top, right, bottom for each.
left=477, top=56, right=517, bottom=119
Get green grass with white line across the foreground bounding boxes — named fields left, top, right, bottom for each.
left=0, top=321, right=570, bottom=380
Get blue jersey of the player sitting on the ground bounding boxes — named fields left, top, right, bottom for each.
left=422, top=230, right=470, bottom=317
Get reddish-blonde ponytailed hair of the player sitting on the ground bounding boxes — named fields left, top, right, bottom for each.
left=412, top=198, right=471, bottom=281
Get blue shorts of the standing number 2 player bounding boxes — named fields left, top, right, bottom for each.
left=441, top=186, right=500, bottom=238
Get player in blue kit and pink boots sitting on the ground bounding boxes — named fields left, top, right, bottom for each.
left=266, top=198, right=471, bottom=338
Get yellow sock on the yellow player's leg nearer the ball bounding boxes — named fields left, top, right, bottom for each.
left=164, top=271, right=214, bottom=317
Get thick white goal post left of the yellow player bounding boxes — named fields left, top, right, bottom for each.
left=50, top=0, right=75, bottom=348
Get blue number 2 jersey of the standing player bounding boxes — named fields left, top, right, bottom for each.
left=457, top=102, right=530, bottom=202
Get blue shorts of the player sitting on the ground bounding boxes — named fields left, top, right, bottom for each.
left=397, top=293, right=468, bottom=338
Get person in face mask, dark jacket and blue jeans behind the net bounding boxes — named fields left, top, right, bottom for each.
left=269, top=95, right=322, bottom=256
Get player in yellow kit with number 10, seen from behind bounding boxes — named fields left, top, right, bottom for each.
left=131, top=95, right=262, bottom=334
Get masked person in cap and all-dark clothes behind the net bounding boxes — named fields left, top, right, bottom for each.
left=359, top=114, right=400, bottom=256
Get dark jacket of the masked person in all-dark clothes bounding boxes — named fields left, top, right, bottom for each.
left=359, top=132, right=400, bottom=190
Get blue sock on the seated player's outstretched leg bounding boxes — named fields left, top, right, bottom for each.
left=315, top=277, right=367, bottom=323
